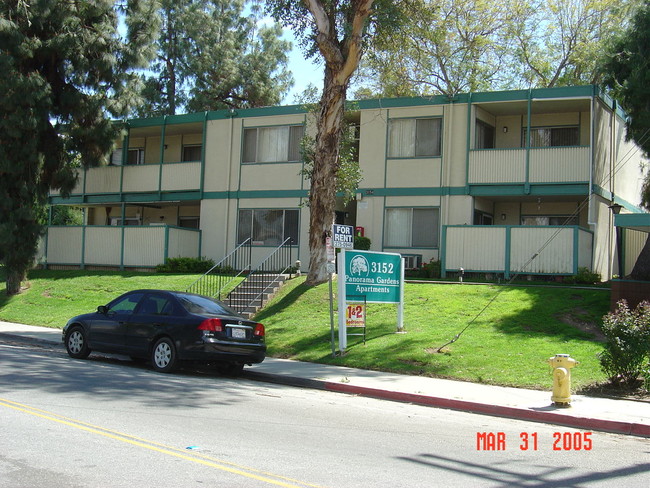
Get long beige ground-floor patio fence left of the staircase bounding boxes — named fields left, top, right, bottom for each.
left=40, top=225, right=201, bottom=268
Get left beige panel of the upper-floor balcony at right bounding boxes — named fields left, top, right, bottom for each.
left=469, top=149, right=526, bottom=184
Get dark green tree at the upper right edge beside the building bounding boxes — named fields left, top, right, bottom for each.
left=603, top=1, right=650, bottom=280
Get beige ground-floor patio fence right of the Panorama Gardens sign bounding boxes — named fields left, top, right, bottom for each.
left=442, top=225, right=593, bottom=278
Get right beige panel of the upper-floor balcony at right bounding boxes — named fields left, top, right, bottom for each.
left=529, top=147, right=589, bottom=183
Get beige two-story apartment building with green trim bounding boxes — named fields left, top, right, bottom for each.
left=41, top=86, right=646, bottom=278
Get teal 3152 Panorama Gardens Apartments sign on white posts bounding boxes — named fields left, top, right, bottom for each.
left=338, top=249, right=404, bottom=352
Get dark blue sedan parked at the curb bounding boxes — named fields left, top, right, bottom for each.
left=63, top=290, right=266, bottom=373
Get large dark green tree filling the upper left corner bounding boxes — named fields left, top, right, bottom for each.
left=0, top=0, right=157, bottom=295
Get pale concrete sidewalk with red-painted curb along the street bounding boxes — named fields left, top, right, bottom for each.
left=0, top=322, right=650, bottom=437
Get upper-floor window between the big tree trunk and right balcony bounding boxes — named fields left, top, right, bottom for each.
left=388, top=118, right=442, bottom=158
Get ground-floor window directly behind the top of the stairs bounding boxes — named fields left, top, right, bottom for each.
left=237, top=209, right=298, bottom=246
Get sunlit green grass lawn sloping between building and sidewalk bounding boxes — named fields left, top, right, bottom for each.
left=0, top=268, right=609, bottom=391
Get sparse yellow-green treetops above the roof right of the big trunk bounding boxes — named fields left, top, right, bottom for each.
left=359, top=0, right=640, bottom=97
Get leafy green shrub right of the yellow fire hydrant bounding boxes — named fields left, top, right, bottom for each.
left=599, top=300, right=650, bottom=389
